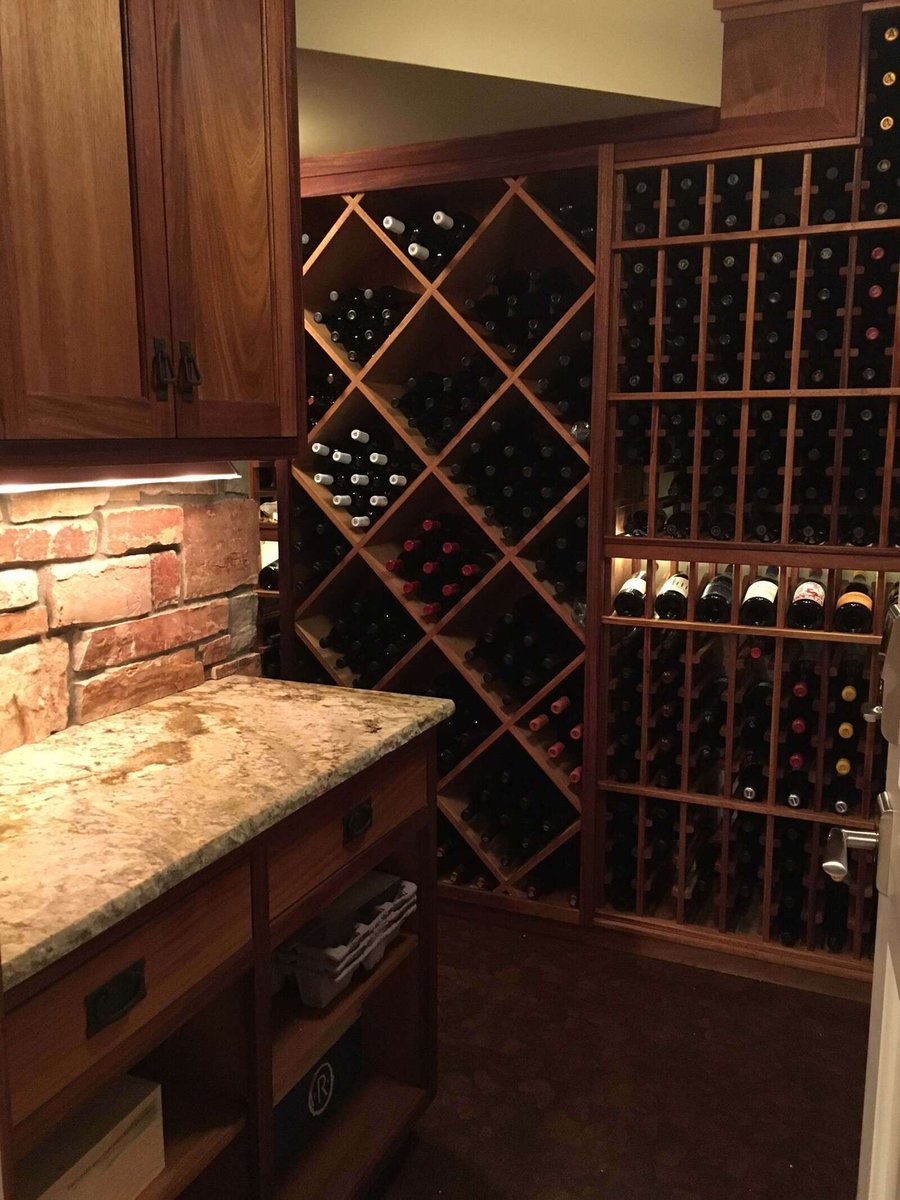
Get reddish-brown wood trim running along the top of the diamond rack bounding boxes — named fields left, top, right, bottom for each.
left=300, top=107, right=719, bottom=197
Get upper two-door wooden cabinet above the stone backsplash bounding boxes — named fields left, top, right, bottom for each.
left=0, top=0, right=298, bottom=440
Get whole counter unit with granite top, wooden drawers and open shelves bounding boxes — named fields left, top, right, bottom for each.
left=0, top=677, right=452, bottom=1200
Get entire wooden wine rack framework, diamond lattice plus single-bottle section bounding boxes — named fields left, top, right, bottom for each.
left=277, top=5, right=900, bottom=979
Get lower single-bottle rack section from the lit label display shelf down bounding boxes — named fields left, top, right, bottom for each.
left=600, top=560, right=896, bottom=958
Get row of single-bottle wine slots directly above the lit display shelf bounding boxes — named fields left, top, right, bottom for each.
left=614, top=397, right=900, bottom=547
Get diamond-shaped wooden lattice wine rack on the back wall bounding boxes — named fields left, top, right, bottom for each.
left=293, top=169, right=596, bottom=920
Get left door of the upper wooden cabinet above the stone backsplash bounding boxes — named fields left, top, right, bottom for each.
left=0, top=0, right=174, bottom=438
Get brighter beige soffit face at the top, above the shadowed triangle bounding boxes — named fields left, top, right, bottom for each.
left=296, top=0, right=721, bottom=104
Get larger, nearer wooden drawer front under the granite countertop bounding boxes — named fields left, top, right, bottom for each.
left=5, top=863, right=251, bottom=1123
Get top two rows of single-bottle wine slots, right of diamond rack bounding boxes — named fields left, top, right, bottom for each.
left=616, top=151, right=900, bottom=397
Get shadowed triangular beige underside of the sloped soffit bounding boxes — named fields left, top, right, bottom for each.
left=298, top=50, right=677, bottom=156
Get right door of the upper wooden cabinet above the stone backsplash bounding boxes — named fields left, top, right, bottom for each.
left=156, top=0, right=296, bottom=438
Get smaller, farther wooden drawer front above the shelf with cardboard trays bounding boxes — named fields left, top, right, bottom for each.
left=269, top=742, right=428, bottom=919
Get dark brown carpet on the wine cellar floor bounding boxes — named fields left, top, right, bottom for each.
left=373, top=919, right=868, bottom=1200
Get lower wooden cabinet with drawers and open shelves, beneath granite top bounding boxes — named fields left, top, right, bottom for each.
left=0, top=733, right=437, bottom=1200
